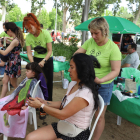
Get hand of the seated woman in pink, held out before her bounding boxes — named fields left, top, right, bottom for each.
left=28, top=97, right=42, bottom=108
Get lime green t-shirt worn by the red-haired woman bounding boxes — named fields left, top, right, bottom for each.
left=26, top=29, right=53, bottom=58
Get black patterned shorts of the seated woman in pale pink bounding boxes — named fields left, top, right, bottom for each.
left=52, top=123, right=90, bottom=140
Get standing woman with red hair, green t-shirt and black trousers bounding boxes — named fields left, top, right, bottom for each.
left=23, top=13, right=53, bottom=101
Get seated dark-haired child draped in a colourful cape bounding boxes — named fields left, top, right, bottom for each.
left=0, top=62, right=44, bottom=138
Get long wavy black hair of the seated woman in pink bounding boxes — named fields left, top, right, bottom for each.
left=71, top=53, right=100, bottom=109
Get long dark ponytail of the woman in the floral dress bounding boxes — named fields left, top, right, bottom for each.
left=5, top=22, right=24, bottom=47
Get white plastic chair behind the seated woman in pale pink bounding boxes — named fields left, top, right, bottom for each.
left=88, top=95, right=104, bottom=140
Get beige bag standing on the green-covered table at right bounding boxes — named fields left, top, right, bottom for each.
left=125, top=79, right=137, bottom=93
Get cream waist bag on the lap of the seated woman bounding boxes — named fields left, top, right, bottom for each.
left=57, top=120, right=85, bottom=137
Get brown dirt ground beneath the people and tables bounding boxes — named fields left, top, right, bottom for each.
left=0, top=69, right=140, bottom=140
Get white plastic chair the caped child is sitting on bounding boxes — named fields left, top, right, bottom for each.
left=3, top=80, right=40, bottom=140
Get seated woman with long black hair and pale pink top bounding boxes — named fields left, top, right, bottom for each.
left=26, top=53, right=100, bottom=140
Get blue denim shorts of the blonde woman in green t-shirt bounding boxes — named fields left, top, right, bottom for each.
left=98, top=81, right=114, bottom=105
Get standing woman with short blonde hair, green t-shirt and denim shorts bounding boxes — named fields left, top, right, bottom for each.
left=75, top=17, right=121, bottom=140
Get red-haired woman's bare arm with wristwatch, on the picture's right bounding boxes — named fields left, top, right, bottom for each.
left=39, top=42, right=52, bottom=67
